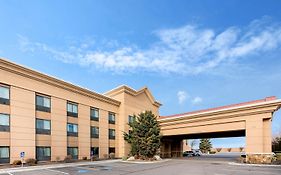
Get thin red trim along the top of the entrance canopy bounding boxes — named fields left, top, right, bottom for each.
left=160, top=96, right=277, bottom=119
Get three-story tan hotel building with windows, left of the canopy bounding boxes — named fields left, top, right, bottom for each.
left=0, top=59, right=161, bottom=163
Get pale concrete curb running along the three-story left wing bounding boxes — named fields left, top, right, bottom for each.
left=0, top=159, right=121, bottom=174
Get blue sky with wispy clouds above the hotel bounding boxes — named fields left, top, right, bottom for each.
left=0, top=0, right=281, bottom=147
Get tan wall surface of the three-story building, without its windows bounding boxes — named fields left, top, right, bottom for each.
left=0, top=59, right=159, bottom=162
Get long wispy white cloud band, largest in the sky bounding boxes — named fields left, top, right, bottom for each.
left=19, top=17, right=281, bottom=75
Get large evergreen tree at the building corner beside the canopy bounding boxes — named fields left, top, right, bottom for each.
left=124, top=111, right=161, bottom=159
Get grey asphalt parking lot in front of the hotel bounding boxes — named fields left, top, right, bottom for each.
left=0, top=156, right=281, bottom=175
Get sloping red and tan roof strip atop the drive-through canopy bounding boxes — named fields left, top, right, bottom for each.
left=159, top=96, right=280, bottom=119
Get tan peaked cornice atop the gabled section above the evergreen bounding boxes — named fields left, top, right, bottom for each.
left=104, top=85, right=162, bottom=107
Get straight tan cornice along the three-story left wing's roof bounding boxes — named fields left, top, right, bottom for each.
left=0, top=57, right=121, bottom=106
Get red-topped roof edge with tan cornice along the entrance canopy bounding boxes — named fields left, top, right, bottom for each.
left=158, top=98, right=281, bottom=121
